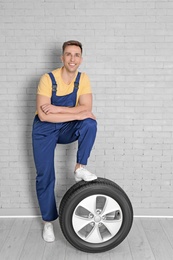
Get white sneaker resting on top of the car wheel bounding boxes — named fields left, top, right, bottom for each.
left=74, top=167, right=97, bottom=182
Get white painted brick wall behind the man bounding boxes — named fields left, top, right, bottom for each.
left=0, top=0, right=173, bottom=215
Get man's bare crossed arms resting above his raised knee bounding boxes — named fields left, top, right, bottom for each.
left=37, top=94, right=96, bottom=123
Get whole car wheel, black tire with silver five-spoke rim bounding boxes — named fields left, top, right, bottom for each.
left=59, top=178, right=133, bottom=253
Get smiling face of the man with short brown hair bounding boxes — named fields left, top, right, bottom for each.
left=61, top=45, right=82, bottom=72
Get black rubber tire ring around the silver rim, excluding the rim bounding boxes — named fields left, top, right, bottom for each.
left=59, top=178, right=133, bottom=253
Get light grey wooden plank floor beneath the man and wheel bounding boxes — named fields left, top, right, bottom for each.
left=0, top=218, right=173, bottom=260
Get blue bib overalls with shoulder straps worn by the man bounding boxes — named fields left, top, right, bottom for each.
left=32, top=72, right=97, bottom=221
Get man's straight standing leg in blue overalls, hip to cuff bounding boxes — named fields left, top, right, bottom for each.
left=32, top=119, right=58, bottom=221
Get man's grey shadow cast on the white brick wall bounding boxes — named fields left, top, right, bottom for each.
left=23, top=45, right=74, bottom=215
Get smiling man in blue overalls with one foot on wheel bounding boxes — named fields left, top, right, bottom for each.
left=32, top=41, right=97, bottom=242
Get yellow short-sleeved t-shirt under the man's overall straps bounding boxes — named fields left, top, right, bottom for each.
left=37, top=68, right=92, bottom=105
